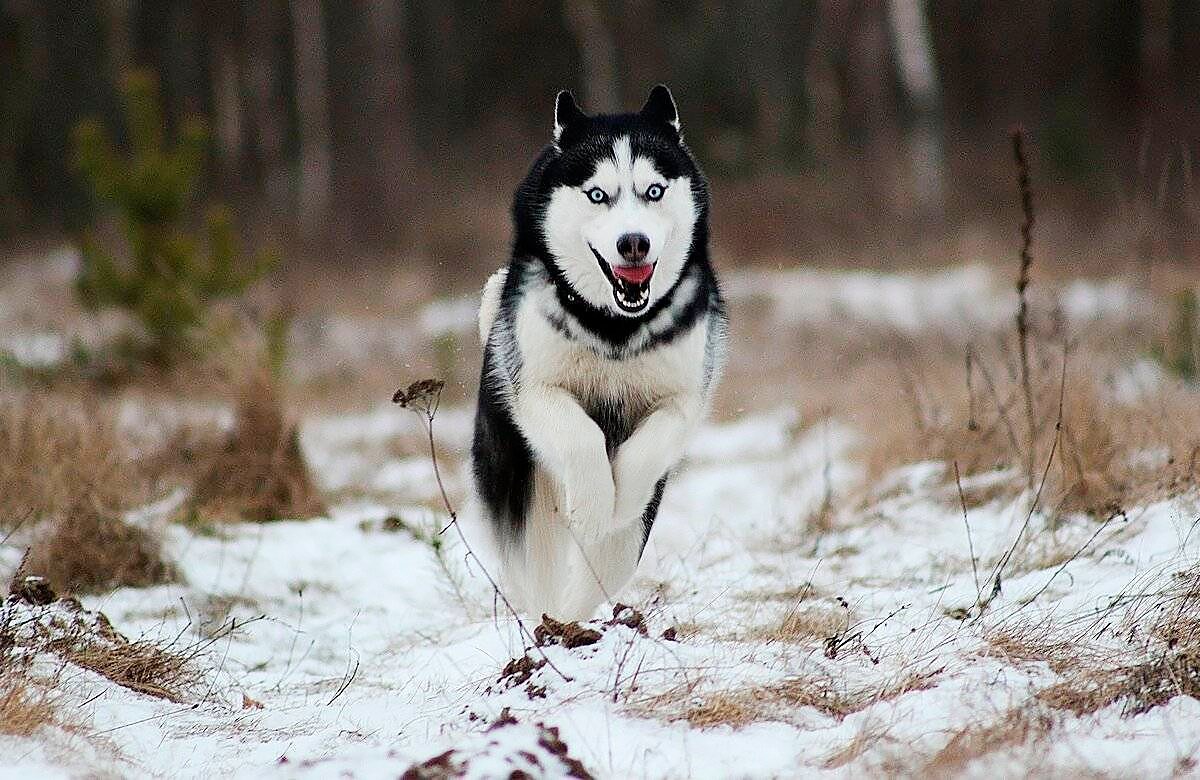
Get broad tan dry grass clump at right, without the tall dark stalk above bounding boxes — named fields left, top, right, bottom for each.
left=862, top=333, right=1200, bottom=517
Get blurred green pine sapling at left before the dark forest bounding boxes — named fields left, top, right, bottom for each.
left=73, top=71, right=276, bottom=366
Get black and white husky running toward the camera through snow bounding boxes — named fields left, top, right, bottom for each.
left=472, top=85, right=726, bottom=619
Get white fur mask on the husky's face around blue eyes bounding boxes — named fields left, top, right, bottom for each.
left=544, top=137, right=697, bottom=316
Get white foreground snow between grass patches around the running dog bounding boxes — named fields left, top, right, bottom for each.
left=8, top=400, right=1200, bottom=778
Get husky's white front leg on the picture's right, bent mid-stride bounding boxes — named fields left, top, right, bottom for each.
left=612, top=396, right=701, bottom=528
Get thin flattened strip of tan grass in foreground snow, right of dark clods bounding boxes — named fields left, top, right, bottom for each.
left=634, top=670, right=941, bottom=728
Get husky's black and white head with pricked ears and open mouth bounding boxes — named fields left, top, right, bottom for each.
left=539, top=85, right=707, bottom=317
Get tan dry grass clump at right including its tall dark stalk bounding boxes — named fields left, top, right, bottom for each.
left=849, top=135, right=1200, bottom=516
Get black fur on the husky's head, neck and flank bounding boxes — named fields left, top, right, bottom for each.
left=472, top=86, right=725, bottom=547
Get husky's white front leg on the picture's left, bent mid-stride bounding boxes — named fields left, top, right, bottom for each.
left=516, top=385, right=614, bottom=544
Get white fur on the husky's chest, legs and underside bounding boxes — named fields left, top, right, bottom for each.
left=480, top=267, right=710, bottom=619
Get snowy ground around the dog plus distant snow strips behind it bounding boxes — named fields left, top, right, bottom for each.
left=0, top=252, right=1200, bottom=778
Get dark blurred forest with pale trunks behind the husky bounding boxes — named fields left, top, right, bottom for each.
left=0, top=0, right=1200, bottom=265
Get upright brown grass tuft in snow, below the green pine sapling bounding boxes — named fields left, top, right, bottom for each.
left=184, top=377, right=325, bottom=522
